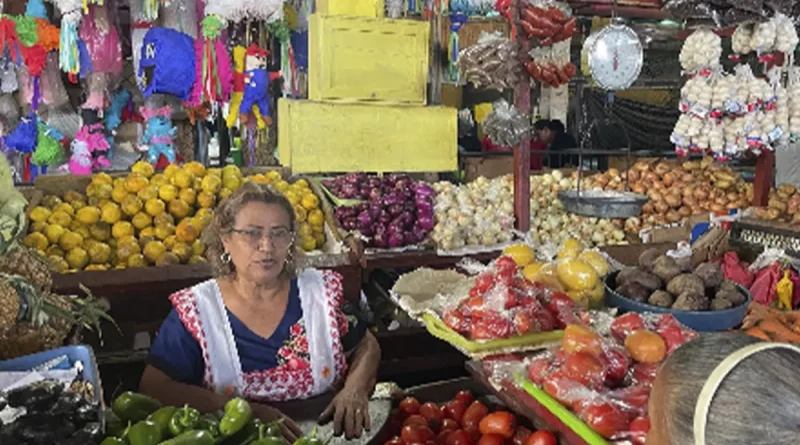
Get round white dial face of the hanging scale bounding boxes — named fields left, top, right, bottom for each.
left=589, top=25, right=644, bottom=90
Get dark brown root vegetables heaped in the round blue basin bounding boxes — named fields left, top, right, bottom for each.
left=615, top=249, right=747, bottom=311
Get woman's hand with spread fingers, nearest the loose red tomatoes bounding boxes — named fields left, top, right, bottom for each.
left=320, top=385, right=370, bottom=439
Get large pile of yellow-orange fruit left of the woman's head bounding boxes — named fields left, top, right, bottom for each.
left=24, top=162, right=245, bottom=272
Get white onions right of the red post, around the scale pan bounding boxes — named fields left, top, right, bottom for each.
left=530, top=169, right=627, bottom=247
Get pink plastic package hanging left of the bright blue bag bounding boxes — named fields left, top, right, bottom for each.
left=78, top=5, right=122, bottom=75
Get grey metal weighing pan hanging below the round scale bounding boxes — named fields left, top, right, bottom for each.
left=558, top=190, right=649, bottom=218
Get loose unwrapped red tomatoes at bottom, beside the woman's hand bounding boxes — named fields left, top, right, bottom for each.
left=384, top=391, right=558, bottom=445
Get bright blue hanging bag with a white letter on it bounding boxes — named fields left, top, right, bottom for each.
left=138, top=28, right=196, bottom=101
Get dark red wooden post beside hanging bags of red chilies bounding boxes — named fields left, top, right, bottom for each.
left=511, top=0, right=531, bottom=233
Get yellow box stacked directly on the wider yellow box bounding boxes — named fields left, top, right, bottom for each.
left=308, top=14, right=430, bottom=105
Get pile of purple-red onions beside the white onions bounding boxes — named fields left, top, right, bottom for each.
left=324, top=173, right=435, bottom=248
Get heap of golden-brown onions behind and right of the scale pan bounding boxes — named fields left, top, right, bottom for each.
left=586, top=157, right=753, bottom=233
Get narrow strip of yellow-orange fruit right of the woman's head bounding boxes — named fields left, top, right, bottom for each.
left=246, top=171, right=325, bottom=252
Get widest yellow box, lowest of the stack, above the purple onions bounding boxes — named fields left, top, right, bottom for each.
left=278, top=99, right=458, bottom=174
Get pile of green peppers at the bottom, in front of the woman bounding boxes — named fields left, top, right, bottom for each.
left=108, top=392, right=314, bottom=445
